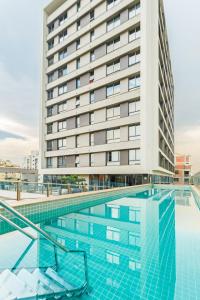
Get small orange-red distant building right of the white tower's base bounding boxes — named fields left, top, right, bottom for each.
left=174, top=154, right=192, bottom=184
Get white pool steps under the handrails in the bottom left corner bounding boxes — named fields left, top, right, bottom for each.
left=0, top=268, right=82, bottom=300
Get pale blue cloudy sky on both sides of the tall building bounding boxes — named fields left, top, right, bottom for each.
left=0, top=0, right=200, bottom=172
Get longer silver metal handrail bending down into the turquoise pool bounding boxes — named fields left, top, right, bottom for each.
left=0, top=200, right=89, bottom=288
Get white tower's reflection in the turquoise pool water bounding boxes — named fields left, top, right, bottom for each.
left=43, top=190, right=176, bottom=300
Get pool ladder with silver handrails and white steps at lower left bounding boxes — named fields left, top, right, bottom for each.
left=0, top=200, right=90, bottom=300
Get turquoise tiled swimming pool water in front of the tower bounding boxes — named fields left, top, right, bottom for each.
left=0, top=188, right=200, bottom=300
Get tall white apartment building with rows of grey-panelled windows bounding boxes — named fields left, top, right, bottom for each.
left=40, top=0, right=174, bottom=185
